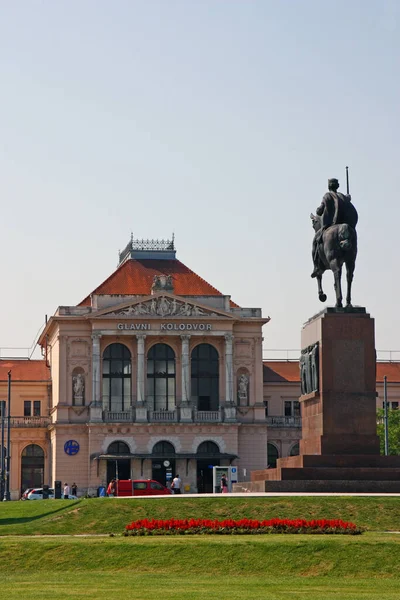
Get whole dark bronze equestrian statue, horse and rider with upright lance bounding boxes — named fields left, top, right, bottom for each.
left=310, top=167, right=358, bottom=308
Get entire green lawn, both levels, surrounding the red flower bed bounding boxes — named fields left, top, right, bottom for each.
left=0, top=497, right=400, bottom=600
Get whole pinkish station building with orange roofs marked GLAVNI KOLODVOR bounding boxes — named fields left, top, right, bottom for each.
left=0, top=240, right=400, bottom=499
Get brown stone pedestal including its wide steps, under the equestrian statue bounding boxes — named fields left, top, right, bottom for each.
left=238, top=308, right=400, bottom=493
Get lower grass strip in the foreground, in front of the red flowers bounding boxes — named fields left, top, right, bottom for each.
left=0, top=533, right=400, bottom=600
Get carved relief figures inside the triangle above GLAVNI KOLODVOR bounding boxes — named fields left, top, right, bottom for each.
left=108, top=296, right=218, bottom=317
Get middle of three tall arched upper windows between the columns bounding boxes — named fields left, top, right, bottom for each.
left=147, top=344, right=175, bottom=410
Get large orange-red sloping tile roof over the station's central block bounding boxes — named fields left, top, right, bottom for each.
left=79, top=259, right=237, bottom=307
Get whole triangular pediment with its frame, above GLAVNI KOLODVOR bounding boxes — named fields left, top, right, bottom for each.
left=88, top=292, right=234, bottom=319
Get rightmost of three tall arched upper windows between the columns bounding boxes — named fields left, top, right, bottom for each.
left=191, top=344, right=219, bottom=411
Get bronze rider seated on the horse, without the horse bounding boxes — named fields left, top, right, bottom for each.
left=311, top=179, right=358, bottom=277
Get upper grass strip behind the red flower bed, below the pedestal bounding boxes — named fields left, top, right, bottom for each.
left=0, top=496, right=400, bottom=536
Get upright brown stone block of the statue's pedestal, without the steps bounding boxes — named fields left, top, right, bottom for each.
left=300, top=308, right=379, bottom=455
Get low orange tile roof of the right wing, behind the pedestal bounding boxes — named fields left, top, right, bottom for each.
left=263, top=360, right=400, bottom=383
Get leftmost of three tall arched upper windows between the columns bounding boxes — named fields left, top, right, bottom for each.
left=103, top=344, right=131, bottom=411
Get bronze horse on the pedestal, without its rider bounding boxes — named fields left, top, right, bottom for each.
left=310, top=213, right=357, bottom=308
